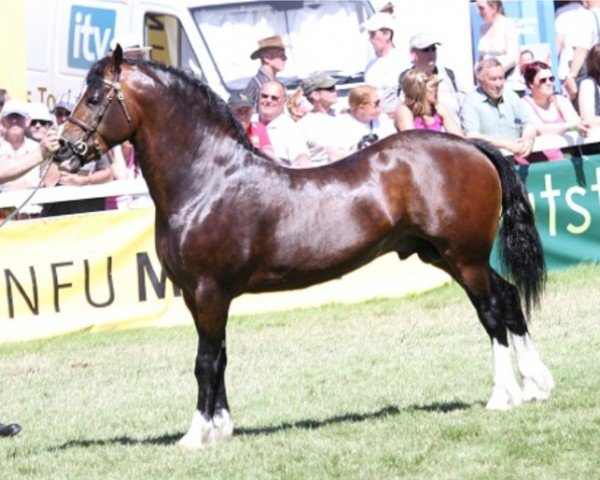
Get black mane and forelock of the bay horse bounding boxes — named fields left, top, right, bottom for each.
left=86, top=56, right=258, bottom=154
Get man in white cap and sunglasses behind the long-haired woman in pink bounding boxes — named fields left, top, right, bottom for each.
left=398, top=32, right=465, bottom=124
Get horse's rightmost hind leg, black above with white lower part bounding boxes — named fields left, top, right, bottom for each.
left=493, top=272, right=554, bottom=401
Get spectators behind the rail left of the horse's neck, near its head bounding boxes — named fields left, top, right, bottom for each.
left=0, top=38, right=149, bottom=219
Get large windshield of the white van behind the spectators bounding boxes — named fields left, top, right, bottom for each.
left=192, top=0, right=373, bottom=90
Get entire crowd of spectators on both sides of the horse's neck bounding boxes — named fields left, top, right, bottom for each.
left=0, top=0, right=600, bottom=216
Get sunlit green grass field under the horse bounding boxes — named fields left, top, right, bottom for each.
left=0, top=266, right=600, bottom=480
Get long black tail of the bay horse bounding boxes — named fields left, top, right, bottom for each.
left=471, top=139, right=546, bottom=316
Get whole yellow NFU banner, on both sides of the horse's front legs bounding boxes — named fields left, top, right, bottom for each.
left=0, top=208, right=448, bottom=343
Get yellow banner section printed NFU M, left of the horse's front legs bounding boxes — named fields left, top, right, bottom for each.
left=0, top=209, right=191, bottom=343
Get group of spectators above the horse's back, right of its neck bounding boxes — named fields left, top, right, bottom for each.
left=232, top=0, right=600, bottom=167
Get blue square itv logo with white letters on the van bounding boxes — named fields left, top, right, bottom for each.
left=68, top=5, right=116, bottom=70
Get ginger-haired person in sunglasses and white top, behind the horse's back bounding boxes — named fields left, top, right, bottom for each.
left=337, top=85, right=396, bottom=152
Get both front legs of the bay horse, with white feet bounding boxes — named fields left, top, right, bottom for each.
left=178, top=285, right=233, bottom=450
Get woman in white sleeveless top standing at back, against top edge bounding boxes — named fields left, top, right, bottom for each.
left=477, top=0, right=519, bottom=86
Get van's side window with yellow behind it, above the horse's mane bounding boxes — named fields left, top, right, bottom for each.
left=144, top=13, right=205, bottom=80
